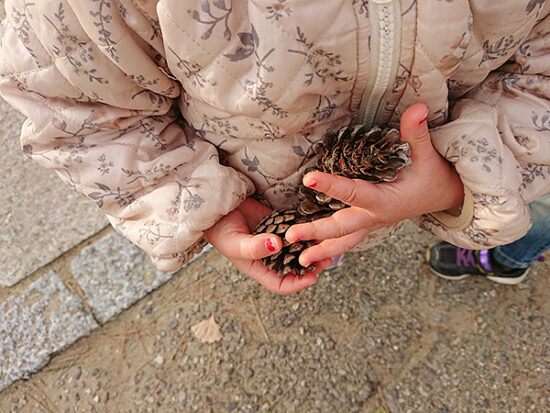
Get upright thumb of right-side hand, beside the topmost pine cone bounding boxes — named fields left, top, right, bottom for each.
left=400, top=103, right=434, bottom=163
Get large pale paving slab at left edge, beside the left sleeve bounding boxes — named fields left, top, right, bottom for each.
left=0, top=97, right=108, bottom=287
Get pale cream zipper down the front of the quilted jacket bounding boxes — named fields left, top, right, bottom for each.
left=359, top=0, right=401, bottom=128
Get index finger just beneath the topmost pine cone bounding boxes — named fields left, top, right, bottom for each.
left=302, top=171, right=380, bottom=208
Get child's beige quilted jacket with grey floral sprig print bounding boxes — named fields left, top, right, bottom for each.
left=0, top=0, right=550, bottom=270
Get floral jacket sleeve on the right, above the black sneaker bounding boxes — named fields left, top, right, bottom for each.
left=420, top=10, right=550, bottom=248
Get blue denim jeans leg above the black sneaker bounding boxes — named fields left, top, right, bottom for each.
left=493, top=194, right=550, bottom=268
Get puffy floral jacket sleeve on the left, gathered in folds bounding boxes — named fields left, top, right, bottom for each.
left=0, top=0, right=254, bottom=271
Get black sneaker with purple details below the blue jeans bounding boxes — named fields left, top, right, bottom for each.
left=426, top=242, right=529, bottom=285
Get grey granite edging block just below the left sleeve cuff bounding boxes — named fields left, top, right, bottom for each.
left=70, top=231, right=211, bottom=323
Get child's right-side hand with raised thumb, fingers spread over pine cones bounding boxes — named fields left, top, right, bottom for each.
left=286, top=103, right=464, bottom=266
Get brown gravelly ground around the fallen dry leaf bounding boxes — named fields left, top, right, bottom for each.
left=0, top=224, right=550, bottom=413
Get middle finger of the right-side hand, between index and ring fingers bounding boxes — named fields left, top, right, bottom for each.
left=285, top=207, right=378, bottom=242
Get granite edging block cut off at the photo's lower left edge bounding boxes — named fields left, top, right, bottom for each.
left=0, top=271, right=98, bottom=390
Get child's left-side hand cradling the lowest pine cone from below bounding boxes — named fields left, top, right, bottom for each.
left=204, top=198, right=331, bottom=294
